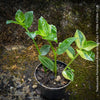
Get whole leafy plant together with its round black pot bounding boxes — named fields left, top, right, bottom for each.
left=6, top=10, right=98, bottom=100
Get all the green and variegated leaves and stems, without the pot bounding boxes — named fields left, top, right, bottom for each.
left=6, top=10, right=97, bottom=81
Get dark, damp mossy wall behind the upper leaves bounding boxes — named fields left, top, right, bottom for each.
left=0, top=0, right=99, bottom=44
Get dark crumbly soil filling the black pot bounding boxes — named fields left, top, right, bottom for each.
left=36, top=63, right=69, bottom=88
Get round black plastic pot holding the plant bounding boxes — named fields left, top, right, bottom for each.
left=34, top=61, right=71, bottom=100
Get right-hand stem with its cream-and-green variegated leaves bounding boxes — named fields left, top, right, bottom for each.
left=62, top=30, right=98, bottom=81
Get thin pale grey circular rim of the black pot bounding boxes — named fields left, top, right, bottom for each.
left=34, top=60, right=71, bottom=90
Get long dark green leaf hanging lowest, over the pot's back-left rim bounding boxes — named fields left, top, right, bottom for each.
left=38, top=55, right=54, bottom=72
